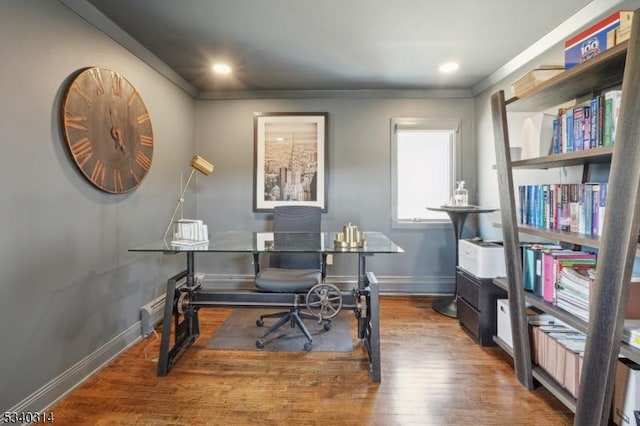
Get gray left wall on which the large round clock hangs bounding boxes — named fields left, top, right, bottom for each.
left=0, top=0, right=195, bottom=411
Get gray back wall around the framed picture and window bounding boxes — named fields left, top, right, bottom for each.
left=196, top=98, right=475, bottom=291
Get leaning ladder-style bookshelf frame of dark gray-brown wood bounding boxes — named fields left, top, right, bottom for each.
left=491, top=11, right=640, bottom=425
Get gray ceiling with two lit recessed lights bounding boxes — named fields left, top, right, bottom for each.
left=61, top=0, right=620, bottom=95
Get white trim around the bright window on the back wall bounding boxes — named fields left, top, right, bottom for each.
left=391, top=117, right=463, bottom=229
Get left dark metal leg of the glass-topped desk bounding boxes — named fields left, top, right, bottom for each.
left=158, top=271, right=200, bottom=376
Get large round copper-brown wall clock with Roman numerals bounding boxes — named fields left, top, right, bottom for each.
left=61, top=67, right=153, bottom=194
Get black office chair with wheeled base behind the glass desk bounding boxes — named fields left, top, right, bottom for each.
left=255, top=206, right=331, bottom=351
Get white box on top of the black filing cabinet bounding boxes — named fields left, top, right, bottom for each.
left=458, top=240, right=506, bottom=278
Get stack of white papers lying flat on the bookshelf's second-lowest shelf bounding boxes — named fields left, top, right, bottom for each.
left=556, top=265, right=595, bottom=321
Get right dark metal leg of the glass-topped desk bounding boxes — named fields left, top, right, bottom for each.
left=358, top=272, right=382, bottom=383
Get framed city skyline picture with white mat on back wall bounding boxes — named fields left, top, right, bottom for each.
left=253, top=112, right=329, bottom=212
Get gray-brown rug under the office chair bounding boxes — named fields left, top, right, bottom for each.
left=205, top=308, right=354, bottom=352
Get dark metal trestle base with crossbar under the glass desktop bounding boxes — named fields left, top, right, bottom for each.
left=158, top=254, right=381, bottom=383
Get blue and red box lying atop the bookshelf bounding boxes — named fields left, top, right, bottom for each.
left=564, top=10, right=633, bottom=69
